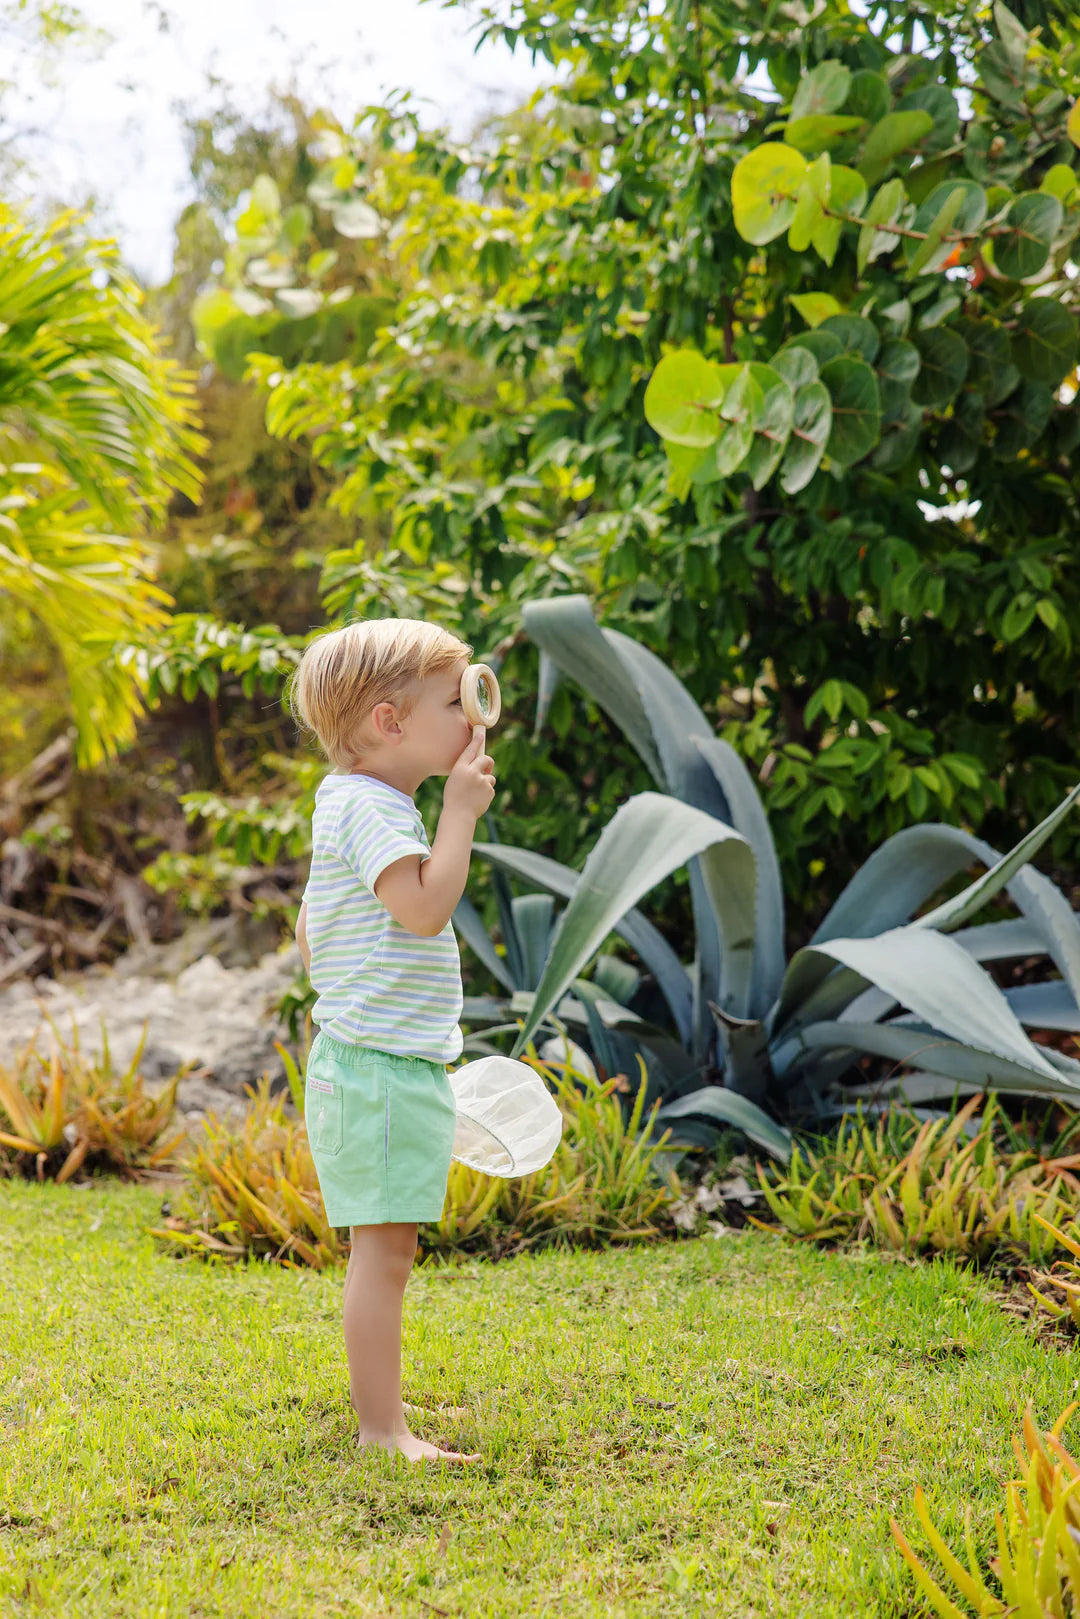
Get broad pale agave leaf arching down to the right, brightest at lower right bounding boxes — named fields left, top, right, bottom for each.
left=785, top=924, right=1052, bottom=1078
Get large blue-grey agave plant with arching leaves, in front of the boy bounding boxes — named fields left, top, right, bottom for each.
left=463, top=596, right=1080, bottom=1159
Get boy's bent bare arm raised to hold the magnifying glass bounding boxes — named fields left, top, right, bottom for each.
left=376, top=725, right=495, bottom=939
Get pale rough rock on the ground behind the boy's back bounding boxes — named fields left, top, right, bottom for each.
left=0, top=918, right=300, bottom=1112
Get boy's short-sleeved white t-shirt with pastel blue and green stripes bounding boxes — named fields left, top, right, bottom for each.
left=304, top=774, right=463, bottom=1062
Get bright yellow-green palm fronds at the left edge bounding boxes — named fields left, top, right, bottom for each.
left=0, top=202, right=202, bottom=764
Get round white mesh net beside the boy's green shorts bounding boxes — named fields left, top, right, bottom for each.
left=450, top=1057, right=562, bottom=1177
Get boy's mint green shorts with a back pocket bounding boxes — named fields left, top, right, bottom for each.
left=304, top=1033, right=457, bottom=1226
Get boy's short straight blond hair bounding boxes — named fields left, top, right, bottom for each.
left=288, top=618, right=473, bottom=769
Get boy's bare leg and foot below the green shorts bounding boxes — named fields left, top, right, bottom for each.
left=343, top=1222, right=473, bottom=1462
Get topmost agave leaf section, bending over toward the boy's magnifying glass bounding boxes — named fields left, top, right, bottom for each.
left=521, top=596, right=662, bottom=787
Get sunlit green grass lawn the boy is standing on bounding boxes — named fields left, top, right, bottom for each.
left=0, top=1182, right=1075, bottom=1619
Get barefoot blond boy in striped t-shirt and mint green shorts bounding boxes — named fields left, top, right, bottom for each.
left=291, top=618, right=495, bottom=1462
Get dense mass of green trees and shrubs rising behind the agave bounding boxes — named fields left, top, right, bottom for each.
left=183, top=0, right=1080, bottom=913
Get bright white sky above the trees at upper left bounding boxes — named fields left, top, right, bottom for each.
left=8, top=0, right=551, bottom=282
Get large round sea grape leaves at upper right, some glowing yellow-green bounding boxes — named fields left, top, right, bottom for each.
left=646, top=5, right=1080, bottom=494
